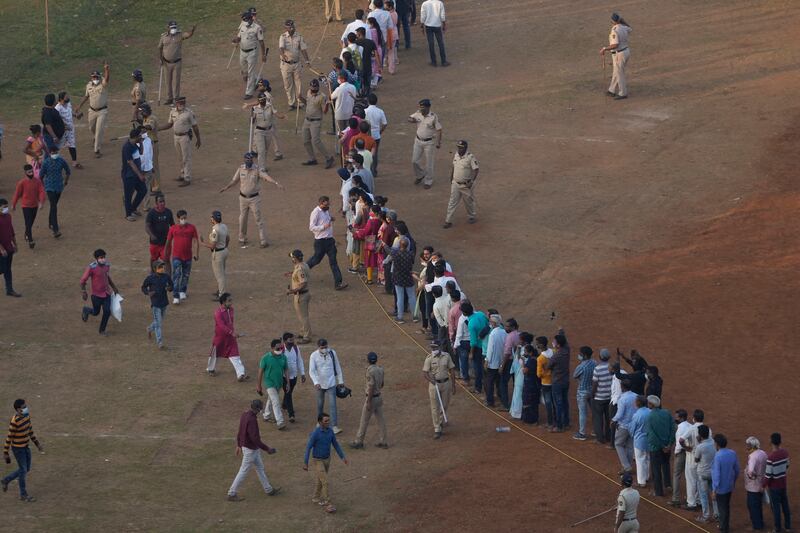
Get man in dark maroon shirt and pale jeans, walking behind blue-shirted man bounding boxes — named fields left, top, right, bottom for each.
left=228, top=399, right=281, bottom=502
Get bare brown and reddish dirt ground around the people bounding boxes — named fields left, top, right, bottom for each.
left=0, top=0, right=800, bottom=532
